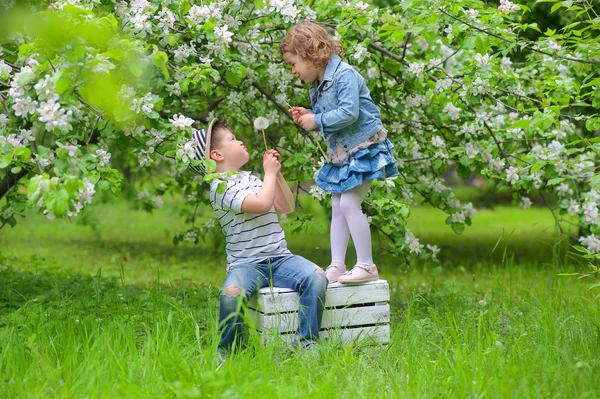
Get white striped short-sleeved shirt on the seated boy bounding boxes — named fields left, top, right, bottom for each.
left=210, top=171, right=292, bottom=266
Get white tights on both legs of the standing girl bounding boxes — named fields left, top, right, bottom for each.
left=329, top=180, right=373, bottom=266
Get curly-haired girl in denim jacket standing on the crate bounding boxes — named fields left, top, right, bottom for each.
left=279, top=23, right=398, bottom=283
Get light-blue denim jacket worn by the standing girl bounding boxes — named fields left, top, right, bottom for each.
left=310, top=54, right=383, bottom=150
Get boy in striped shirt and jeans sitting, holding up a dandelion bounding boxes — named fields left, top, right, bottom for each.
left=192, top=119, right=327, bottom=352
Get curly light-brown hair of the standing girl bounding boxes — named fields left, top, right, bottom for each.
left=278, top=22, right=344, bottom=67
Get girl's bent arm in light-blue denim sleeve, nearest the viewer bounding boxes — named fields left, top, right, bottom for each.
left=315, top=69, right=359, bottom=133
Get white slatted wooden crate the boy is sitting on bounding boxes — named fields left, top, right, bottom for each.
left=249, top=280, right=390, bottom=343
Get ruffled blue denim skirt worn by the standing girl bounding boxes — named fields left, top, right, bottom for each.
left=315, top=139, right=398, bottom=194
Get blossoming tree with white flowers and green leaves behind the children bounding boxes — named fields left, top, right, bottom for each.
left=0, top=0, right=600, bottom=258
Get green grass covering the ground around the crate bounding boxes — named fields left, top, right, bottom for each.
left=0, top=198, right=600, bottom=399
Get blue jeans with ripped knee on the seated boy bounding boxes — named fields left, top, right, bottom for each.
left=219, top=255, right=327, bottom=350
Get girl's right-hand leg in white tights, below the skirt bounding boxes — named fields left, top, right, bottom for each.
left=339, top=180, right=373, bottom=266
